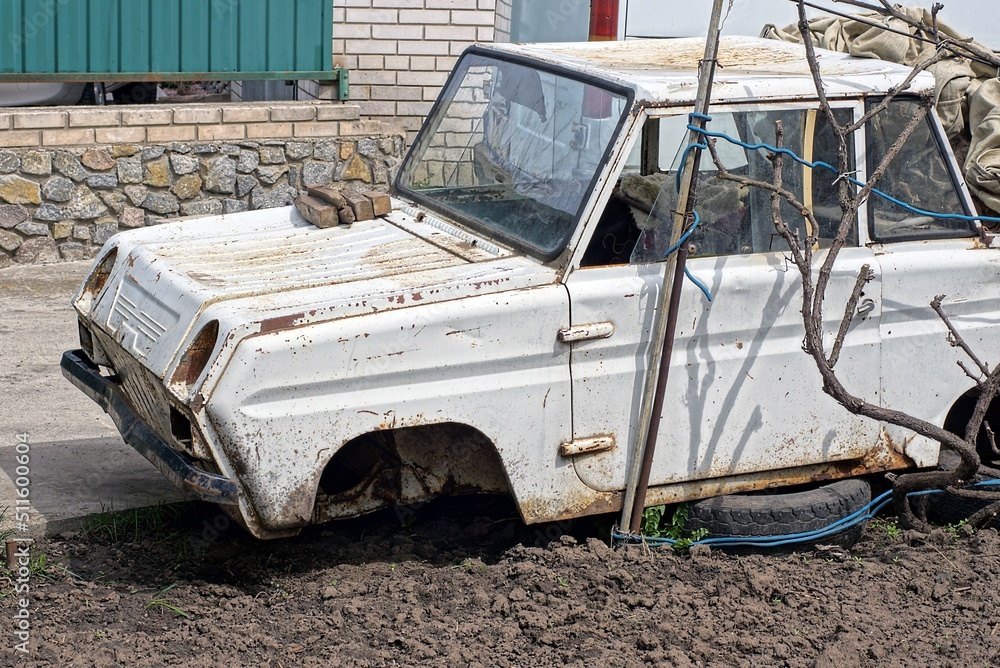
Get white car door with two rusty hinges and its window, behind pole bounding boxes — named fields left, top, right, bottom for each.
left=566, top=106, right=881, bottom=491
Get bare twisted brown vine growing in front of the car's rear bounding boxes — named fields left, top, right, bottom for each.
left=708, top=0, right=1000, bottom=531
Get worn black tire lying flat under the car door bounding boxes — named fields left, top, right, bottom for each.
left=687, top=478, right=872, bottom=552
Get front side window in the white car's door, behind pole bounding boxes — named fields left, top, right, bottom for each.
left=582, top=109, right=857, bottom=267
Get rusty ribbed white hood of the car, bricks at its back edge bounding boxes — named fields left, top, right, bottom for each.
left=77, top=201, right=557, bottom=378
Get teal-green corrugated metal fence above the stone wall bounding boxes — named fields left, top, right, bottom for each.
left=0, top=0, right=347, bottom=99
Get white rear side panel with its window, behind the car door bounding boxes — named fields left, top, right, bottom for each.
left=868, top=98, right=1000, bottom=466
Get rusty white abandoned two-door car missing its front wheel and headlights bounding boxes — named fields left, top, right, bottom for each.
left=63, top=38, right=1000, bottom=538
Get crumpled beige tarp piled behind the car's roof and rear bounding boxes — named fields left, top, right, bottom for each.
left=761, top=5, right=1000, bottom=211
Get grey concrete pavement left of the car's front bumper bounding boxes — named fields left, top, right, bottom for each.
left=0, top=262, right=185, bottom=536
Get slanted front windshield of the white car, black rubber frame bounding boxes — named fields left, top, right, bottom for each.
left=397, top=53, right=629, bottom=259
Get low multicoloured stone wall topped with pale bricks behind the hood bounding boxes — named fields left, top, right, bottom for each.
left=0, top=103, right=404, bottom=268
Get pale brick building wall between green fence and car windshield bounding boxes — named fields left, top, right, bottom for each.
left=333, top=0, right=500, bottom=138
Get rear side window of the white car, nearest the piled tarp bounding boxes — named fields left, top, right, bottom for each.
left=868, top=99, right=975, bottom=241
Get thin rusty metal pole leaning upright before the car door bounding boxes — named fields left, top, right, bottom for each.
left=621, top=0, right=726, bottom=532
